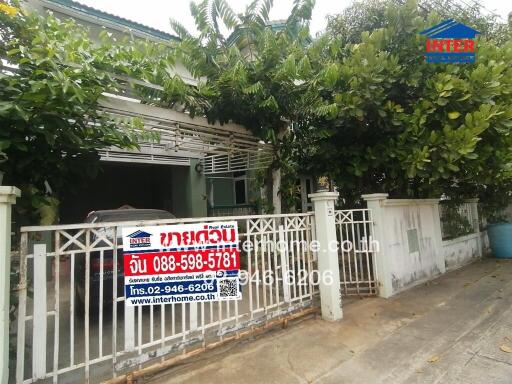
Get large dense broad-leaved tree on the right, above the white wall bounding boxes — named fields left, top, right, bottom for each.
left=296, top=1, right=512, bottom=207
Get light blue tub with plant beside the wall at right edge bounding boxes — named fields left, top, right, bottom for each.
left=486, top=201, right=512, bottom=259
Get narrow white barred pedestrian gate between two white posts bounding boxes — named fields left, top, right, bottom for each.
left=335, top=209, right=378, bottom=296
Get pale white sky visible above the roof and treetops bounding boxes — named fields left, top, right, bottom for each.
left=78, top=0, right=512, bottom=35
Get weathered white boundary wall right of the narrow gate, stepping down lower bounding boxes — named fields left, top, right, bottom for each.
left=363, top=193, right=484, bottom=297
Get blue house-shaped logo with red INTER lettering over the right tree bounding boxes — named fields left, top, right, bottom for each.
left=421, top=19, right=480, bottom=63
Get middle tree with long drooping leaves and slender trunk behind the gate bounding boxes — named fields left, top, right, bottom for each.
left=171, top=0, right=314, bottom=211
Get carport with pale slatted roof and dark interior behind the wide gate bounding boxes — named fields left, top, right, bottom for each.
left=60, top=94, right=272, bottom=224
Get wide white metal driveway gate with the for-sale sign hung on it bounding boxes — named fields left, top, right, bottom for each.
left=16, top=213, right=318, bottom=383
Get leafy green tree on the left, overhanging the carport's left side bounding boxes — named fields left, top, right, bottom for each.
left=0, top=6, right=155, bottom=221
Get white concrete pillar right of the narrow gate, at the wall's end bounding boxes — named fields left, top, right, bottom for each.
left=362, top=193, right=393, bottom=298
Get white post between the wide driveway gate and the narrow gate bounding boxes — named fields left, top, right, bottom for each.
left=309, top=192, right=343, bottom=321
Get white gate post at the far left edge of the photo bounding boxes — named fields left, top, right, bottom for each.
left=0, top=186, right=21, bottom=383
